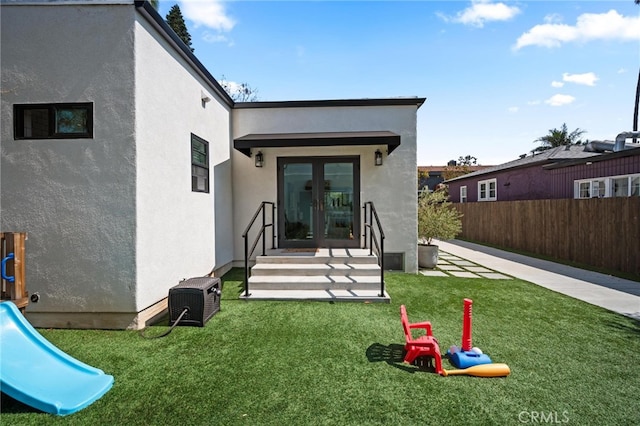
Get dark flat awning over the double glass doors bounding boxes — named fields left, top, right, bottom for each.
left=233, top=131, right=400, bottom=157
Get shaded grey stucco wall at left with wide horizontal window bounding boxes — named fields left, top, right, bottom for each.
left=0, top=4, right=136, bottom=320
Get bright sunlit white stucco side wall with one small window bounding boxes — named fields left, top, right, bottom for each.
left=135, top=18, right=233, bottom=310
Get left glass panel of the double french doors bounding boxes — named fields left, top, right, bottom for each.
left=282, top=163, right=315, bottom=241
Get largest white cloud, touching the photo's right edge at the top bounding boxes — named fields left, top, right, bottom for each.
left=514, top=9, right=640, bottom=50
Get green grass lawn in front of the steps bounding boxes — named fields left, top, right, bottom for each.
left=0, top=269, right=640, bottom=426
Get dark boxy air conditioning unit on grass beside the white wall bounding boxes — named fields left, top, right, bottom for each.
left=169, top=277, right=222, bottom=327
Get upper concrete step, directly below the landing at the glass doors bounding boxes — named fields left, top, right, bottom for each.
left=251, top=262, right=380, bottom=277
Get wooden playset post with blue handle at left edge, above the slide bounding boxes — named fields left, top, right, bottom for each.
left=0, top=232, right=29, bottom=312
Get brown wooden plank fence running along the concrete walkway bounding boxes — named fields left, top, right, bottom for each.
left=454, top=197, right=640, bottom=277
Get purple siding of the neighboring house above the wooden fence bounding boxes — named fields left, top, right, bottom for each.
left=449, top=155, right=640, bottom=203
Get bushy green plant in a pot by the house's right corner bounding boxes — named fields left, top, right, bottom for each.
left=418, top=190, right=462, bottom=268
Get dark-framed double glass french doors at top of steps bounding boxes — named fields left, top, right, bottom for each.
left=278, top=157, right=360, bottom=248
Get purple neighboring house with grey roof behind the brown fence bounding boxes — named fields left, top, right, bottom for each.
left=446, top=142, right=640, bottom=203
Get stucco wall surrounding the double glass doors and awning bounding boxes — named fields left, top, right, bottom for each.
left=232, top=106, right=417, bottom=272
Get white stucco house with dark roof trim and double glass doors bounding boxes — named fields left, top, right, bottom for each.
left=0, top=0, right=425, bottom=328
